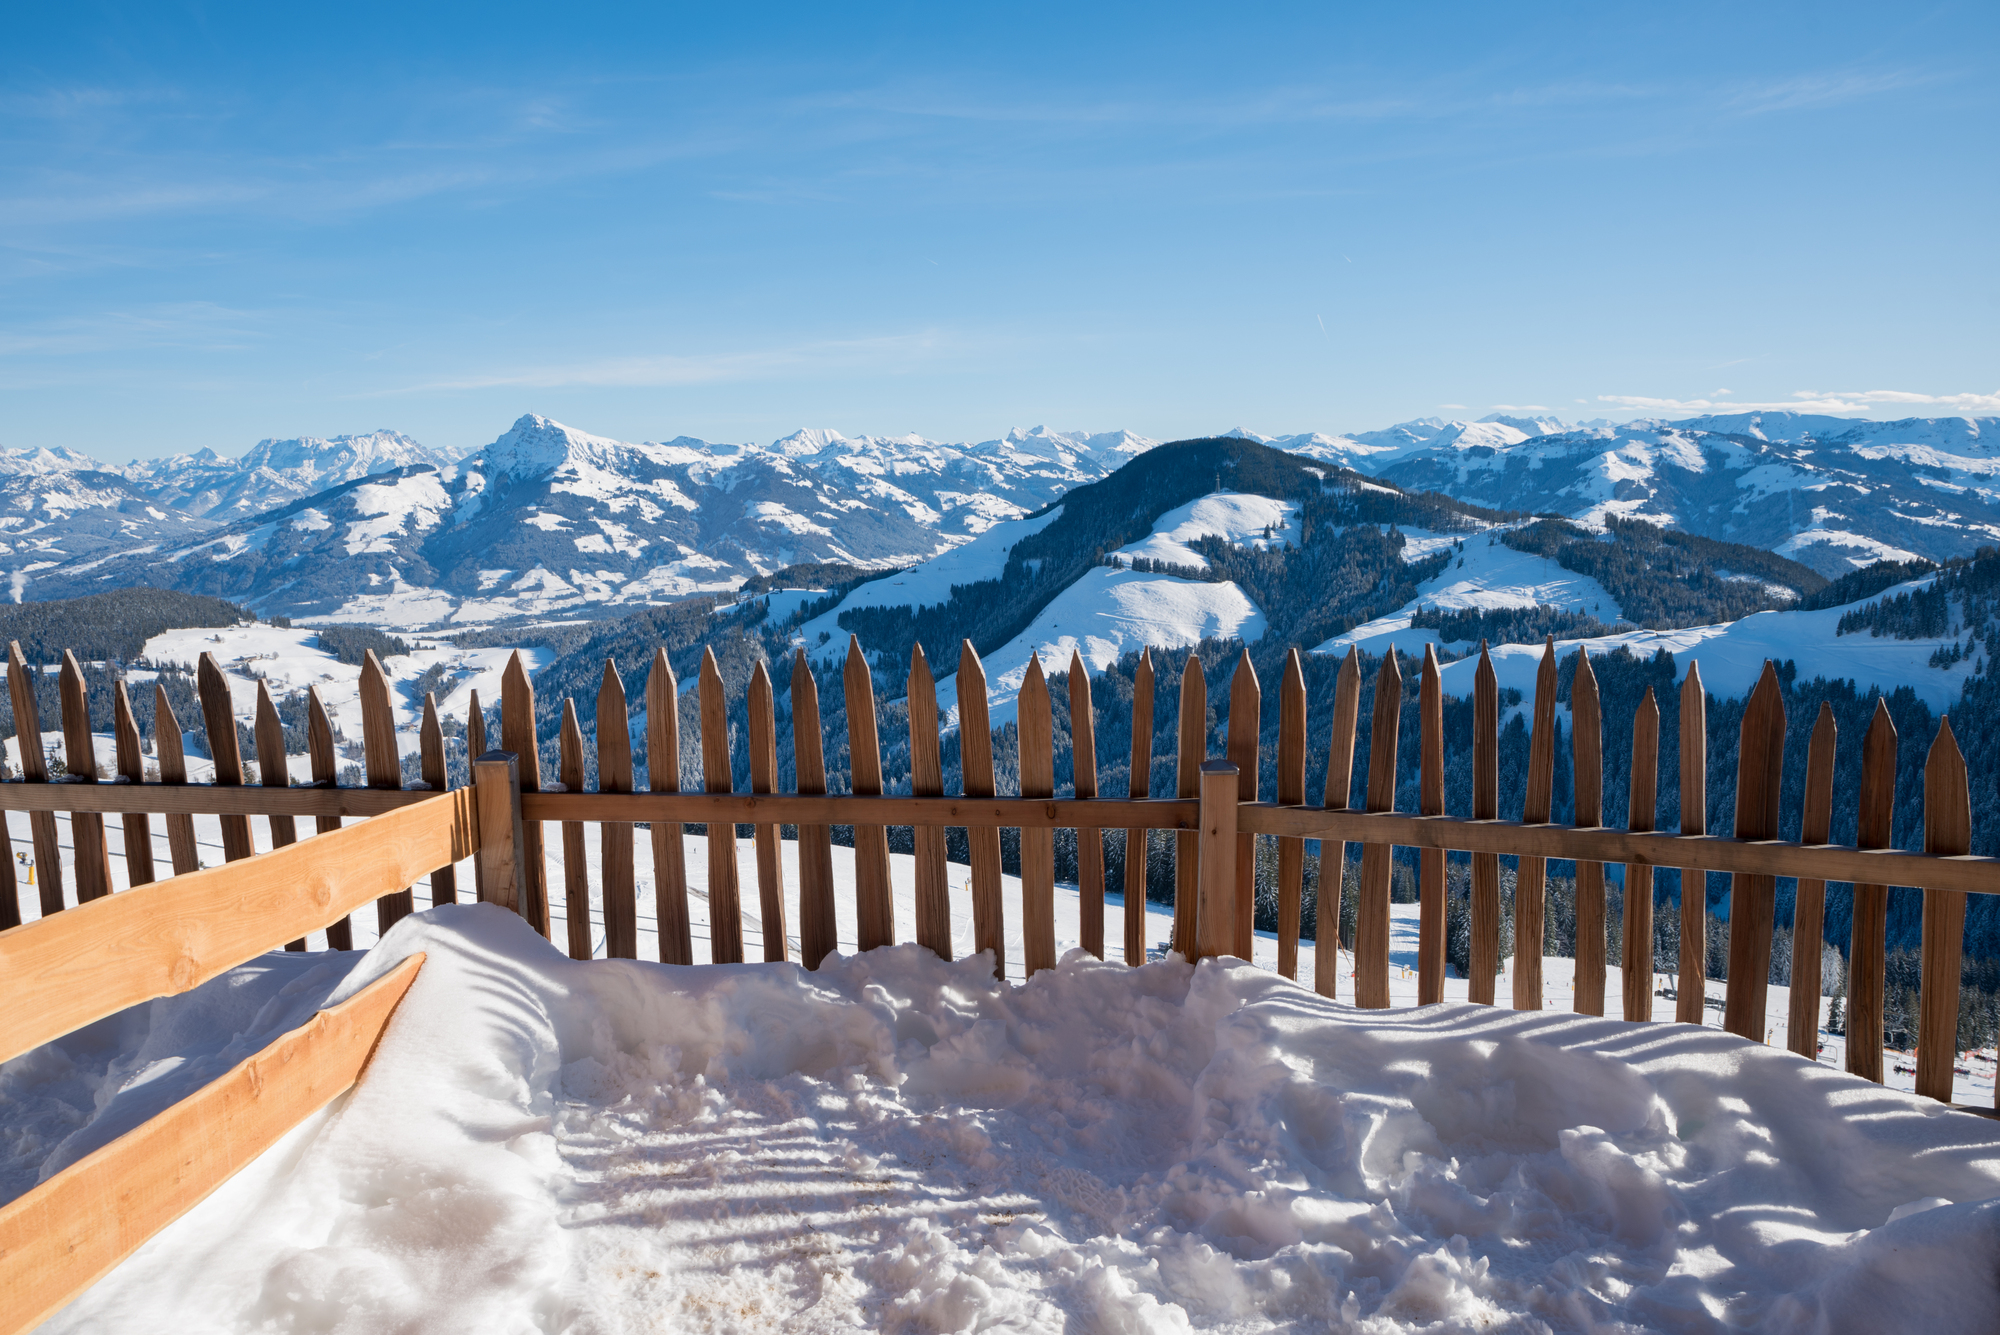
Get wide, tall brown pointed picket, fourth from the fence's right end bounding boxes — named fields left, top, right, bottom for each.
left=1722, top=658, right=1784, bottom=1043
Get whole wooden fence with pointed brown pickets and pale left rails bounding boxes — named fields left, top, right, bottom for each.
left=0, top=642, right=2000, bottom=1333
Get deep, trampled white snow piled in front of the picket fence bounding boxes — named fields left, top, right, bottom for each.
left=23, top=905, right=2000, bottom=1333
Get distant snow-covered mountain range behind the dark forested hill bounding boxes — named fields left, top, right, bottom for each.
left=15, top=414, right=2000, bottom=626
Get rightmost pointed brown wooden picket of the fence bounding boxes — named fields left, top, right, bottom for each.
left=1916, top=715, right=1968, bottom=1103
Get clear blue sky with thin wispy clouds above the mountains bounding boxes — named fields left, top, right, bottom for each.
left=0, top=0, right=2000, bottom=460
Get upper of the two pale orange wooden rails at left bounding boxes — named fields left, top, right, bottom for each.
left=0, top=791, right=478, bottom=1061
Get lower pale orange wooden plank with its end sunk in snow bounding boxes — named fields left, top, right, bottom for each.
left=0, top=955, right=424, bottom=1335
